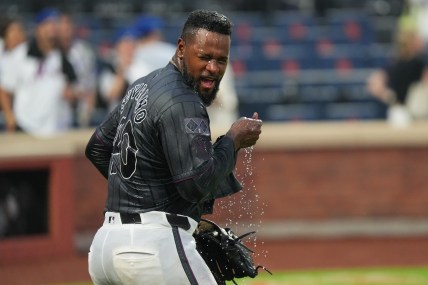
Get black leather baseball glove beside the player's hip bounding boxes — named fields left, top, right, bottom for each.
left=194, top=219, right=272, bottom=285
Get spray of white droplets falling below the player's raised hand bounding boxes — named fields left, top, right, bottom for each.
left=217, top=147, right=267, bottom=258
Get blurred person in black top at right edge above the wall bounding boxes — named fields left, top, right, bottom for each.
left=367, top=29, right=428, bottom=123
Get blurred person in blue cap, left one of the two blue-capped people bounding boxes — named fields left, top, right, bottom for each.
left=98, top=27, right=144, bottom=112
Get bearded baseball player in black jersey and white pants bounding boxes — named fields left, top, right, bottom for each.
left=86, top=10, right=262, bottom=285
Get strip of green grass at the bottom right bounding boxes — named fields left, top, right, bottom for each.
left=54, top=266, right=428, bottom=285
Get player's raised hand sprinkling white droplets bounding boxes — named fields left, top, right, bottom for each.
left=226, top=112, right=263, bottom=150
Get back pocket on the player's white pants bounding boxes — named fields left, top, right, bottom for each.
left=113, top=248, right=163, bottom=285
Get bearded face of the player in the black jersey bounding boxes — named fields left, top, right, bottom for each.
left=178, top=29, right=230, bottom=106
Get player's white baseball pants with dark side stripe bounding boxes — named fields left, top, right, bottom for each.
left=88, top=211, right=217, bottom=285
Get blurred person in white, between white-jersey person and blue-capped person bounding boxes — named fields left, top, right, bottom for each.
left=58, top=12, right=97, bottom=127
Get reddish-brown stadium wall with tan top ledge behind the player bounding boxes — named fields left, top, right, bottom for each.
left=0, top=122, right=428, bottom=268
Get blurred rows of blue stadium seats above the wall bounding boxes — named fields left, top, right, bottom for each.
left=0, top=0, right=412, bottom=124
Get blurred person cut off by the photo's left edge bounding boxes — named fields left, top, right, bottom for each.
left=0, top=18, right=27, bottom=131
